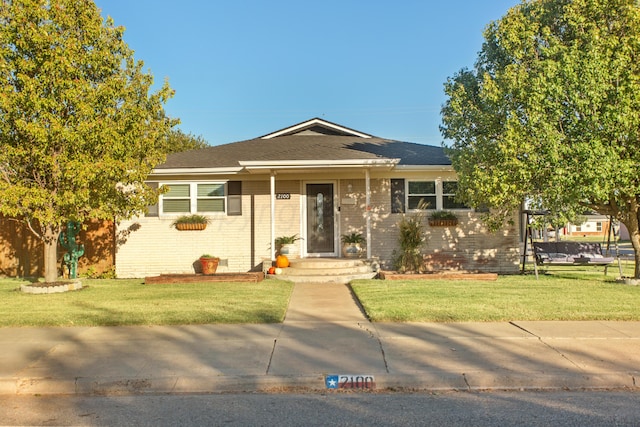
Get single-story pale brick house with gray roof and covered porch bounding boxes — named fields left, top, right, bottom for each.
left=116, top=118, right=520, bottom=278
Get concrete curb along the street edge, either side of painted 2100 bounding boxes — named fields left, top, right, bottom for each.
left=0, top=371, right=640, bottom=395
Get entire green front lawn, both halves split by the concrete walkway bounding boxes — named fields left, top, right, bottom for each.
left=0, top=263, right=640, bottom=327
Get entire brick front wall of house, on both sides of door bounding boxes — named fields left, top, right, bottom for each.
left=116, top=178, right=519, bottom=278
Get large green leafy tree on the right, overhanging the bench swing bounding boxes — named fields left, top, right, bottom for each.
left=441, top=0, right=640, bottom=277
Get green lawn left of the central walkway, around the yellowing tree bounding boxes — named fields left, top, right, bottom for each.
left=0, top=279, right=293, bottom=327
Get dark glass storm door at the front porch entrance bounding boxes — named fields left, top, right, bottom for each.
left=305, top=184, right=335, bottom=256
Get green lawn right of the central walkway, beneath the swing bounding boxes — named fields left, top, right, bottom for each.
left=351, top=271, right=640, bottom=322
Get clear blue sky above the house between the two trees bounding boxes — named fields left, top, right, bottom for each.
left=95, top=0, right=519, bottom=145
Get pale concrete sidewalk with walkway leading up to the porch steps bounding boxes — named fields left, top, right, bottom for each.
left=0, top=284, right=640, bottom=394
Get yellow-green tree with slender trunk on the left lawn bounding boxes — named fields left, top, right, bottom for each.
left=0, top=0, right=175, bottom=281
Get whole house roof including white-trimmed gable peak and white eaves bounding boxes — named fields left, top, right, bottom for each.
left=155, top=118, right=451, bottom=174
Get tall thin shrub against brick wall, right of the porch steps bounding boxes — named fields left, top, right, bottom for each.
left=393, top=212, right=426, bottom=273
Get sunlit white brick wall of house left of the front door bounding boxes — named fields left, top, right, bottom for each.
left=116, top=180, right=300, bottom=278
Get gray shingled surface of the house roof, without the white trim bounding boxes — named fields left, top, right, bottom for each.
left=156, top=119, right=451, bottom=169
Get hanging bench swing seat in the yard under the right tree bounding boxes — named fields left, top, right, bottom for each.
left=533, top=242, right=615, bottom=266
